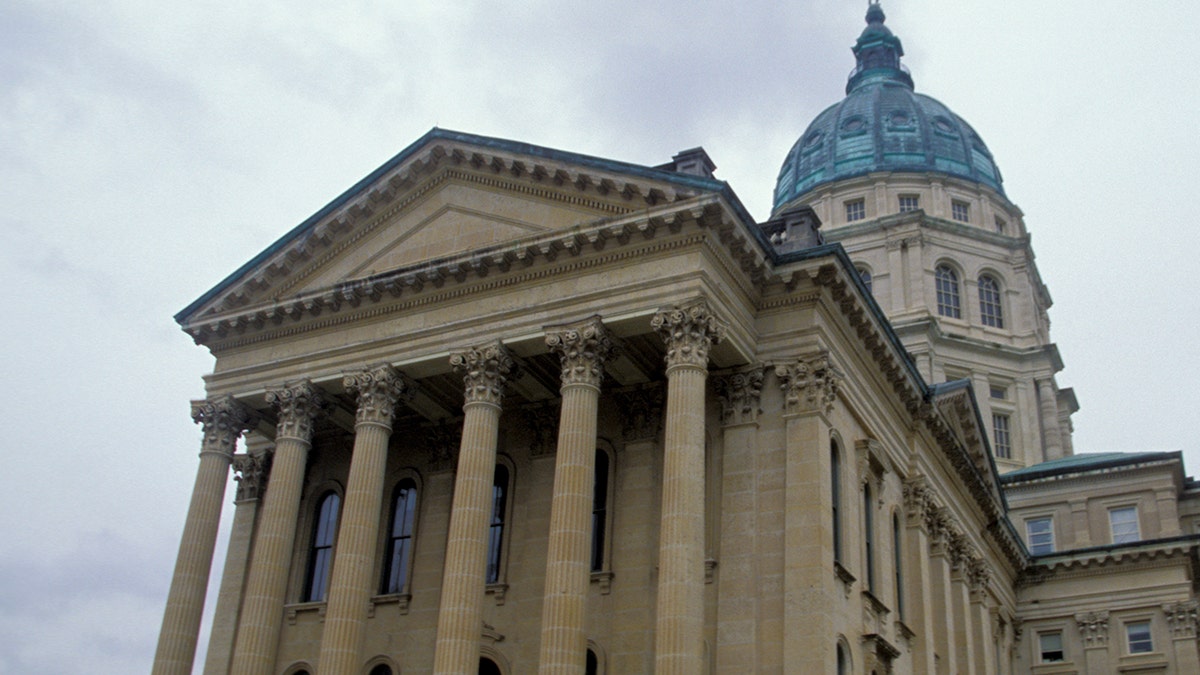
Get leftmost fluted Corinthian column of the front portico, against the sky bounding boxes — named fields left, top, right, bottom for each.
left=152, top=396, right=253, bottom=675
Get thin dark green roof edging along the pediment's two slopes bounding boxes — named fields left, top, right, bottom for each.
left=174, top=127, right=755, bottom=324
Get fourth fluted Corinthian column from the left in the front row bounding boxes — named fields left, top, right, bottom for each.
left=433, top=342, right=516, bottom=675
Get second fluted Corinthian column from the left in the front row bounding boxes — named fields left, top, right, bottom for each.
left=233, top=381, right=323, bottom=675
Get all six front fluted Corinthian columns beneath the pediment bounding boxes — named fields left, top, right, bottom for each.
left=154, top=300, right=725, bottom=675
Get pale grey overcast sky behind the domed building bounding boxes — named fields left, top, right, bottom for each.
left=0, top=0, right=1200, bottom=675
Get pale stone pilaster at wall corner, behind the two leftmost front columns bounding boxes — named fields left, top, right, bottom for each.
left=204, top=454, right=270, bottom=675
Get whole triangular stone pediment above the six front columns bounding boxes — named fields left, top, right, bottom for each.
left=175, top=130, right=726, bottom=327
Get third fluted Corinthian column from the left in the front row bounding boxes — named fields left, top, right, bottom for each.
left=317, top=364, right=412, bottom=675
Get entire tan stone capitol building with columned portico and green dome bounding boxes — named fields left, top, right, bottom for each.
left=154, top=1, right=1200, bottom=675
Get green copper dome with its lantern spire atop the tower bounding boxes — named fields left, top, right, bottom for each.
left=774, top=1, right=1004, bottom=208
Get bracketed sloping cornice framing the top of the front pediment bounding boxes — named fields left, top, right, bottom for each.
left=175, top=130, right=724, bottom=328
